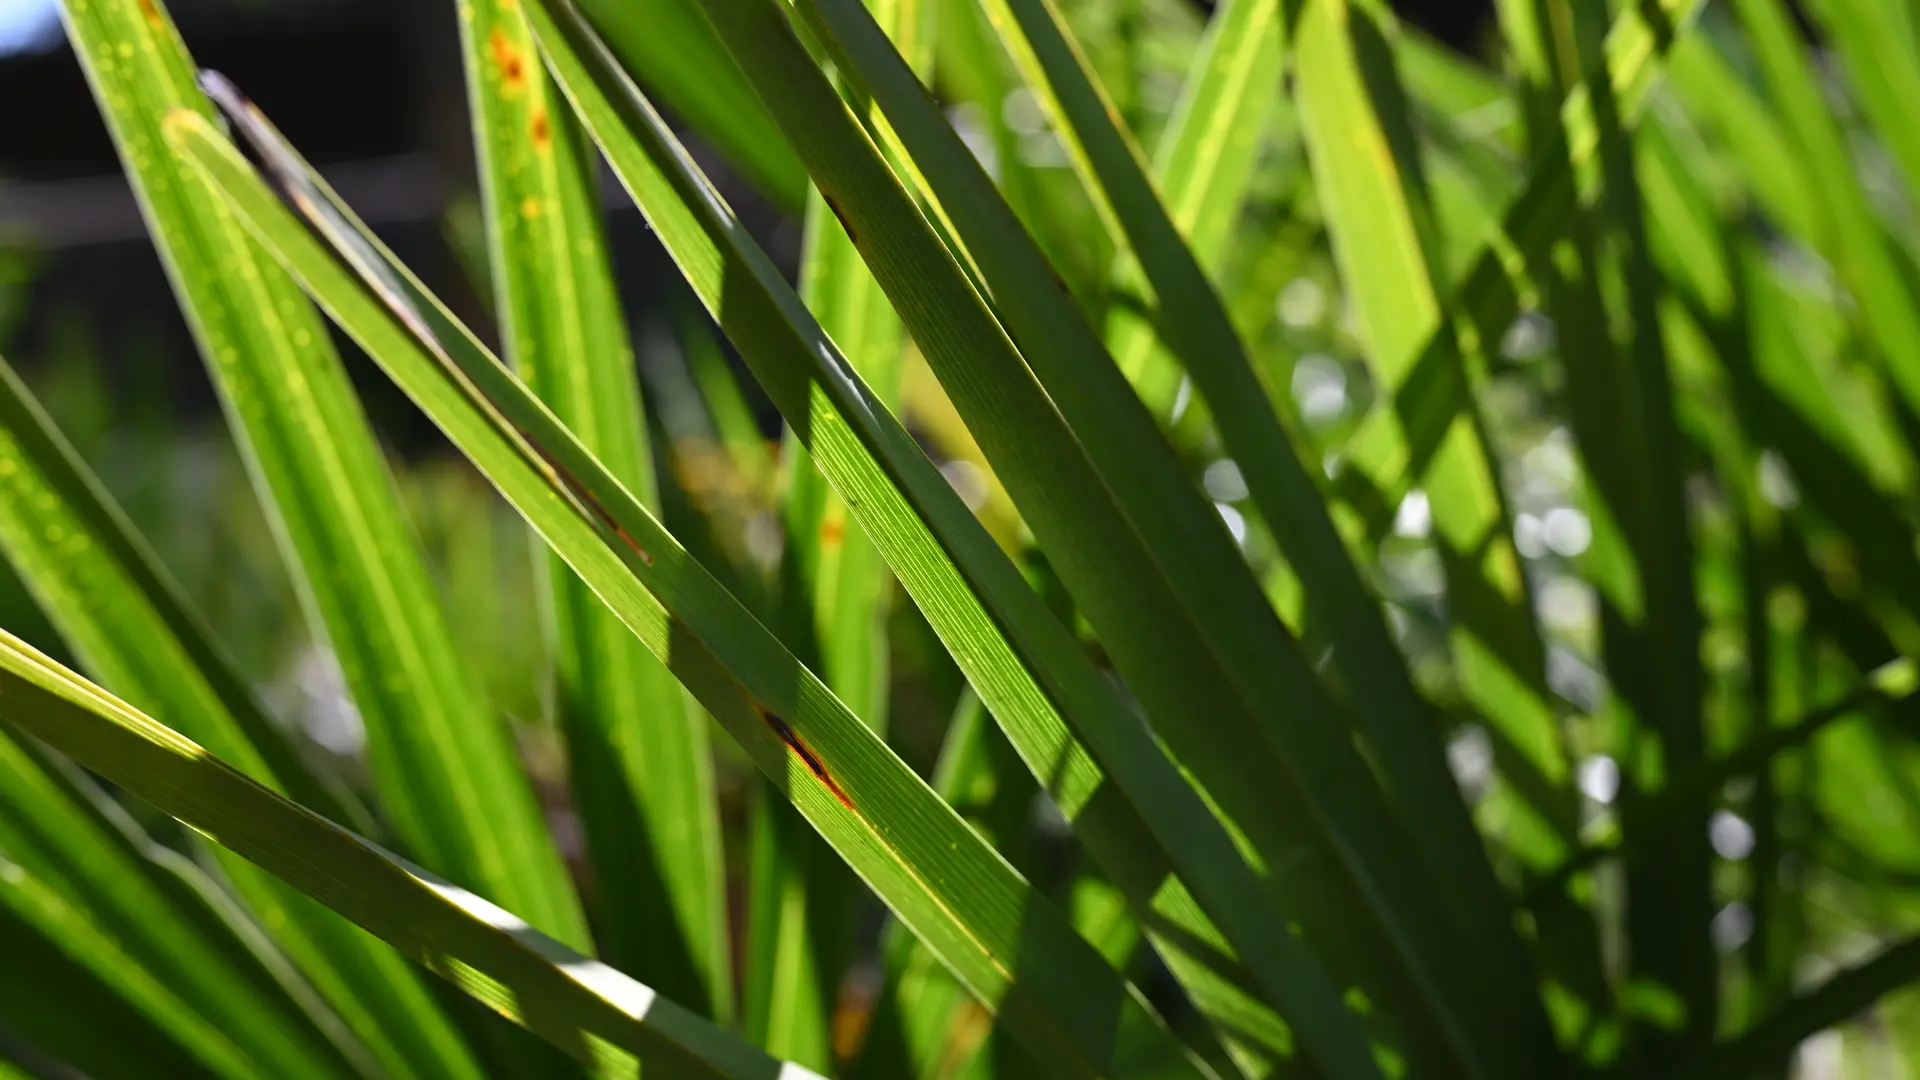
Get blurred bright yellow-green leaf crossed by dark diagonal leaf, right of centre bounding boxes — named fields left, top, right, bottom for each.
left=1294, top=0, right=1569, bottom=1074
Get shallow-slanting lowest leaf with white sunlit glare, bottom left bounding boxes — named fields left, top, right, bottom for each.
left=0, top=632, right=816, bottom=1080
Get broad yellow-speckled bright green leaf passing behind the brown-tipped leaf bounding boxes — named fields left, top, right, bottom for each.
left=67, top=0, right=586, bottom=942
